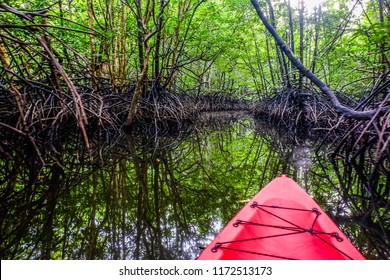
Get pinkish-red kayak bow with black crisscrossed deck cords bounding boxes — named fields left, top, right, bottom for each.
left=197, top=175, right=365, bottom=260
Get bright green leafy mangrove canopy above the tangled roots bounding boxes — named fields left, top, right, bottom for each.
left=0, top=0, right=390, bottom=96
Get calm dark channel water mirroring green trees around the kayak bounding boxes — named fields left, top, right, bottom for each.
left=0, top=113, right=390, bottom=259
